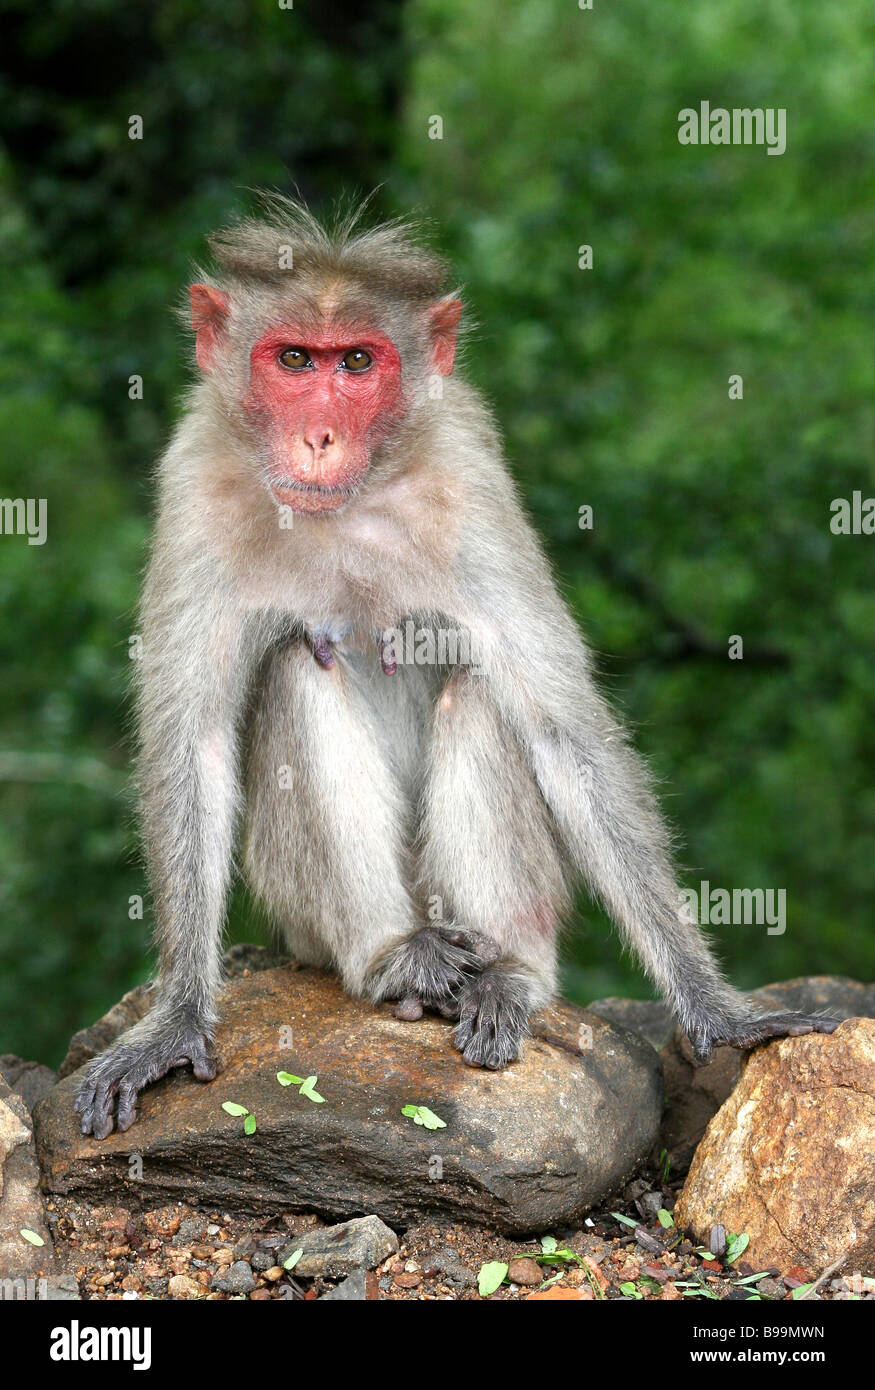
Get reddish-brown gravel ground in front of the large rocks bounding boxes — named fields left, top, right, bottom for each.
left=47, top=1175, right=875, bottom=1302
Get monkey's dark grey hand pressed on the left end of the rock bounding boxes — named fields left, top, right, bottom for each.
left=72, top=1024, right=216, bottom=1138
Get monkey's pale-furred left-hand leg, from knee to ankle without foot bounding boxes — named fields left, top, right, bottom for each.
left=245, top=641, right=417, bottom=995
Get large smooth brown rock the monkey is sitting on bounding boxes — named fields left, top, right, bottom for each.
left=35, top=967, right=662, bottom=1233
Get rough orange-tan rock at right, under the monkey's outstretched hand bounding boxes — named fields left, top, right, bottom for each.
left=675, top=1019, right=875, bottom=1277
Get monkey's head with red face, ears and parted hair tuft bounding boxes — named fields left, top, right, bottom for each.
left=189, top=199, right=462, bottom=514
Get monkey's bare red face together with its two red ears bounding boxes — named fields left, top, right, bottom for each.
left=191, top=285, right=462, bottom=513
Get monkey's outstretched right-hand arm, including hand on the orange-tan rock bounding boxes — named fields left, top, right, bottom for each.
left=450, top=496, right=836, bottom=1061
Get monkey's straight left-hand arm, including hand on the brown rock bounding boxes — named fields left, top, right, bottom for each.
left=75, top=538, right=256, bottom=1138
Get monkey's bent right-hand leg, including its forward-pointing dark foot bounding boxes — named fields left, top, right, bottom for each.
left=408, top=671, right=568, bottom=1068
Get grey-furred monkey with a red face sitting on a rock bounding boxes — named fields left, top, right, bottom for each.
left=74, top=195, right=836, bottom=1138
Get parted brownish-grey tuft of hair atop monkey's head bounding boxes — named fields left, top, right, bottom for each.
left=209, top=193, right=449, bottom=304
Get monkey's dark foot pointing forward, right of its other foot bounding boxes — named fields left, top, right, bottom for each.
left=453, top=962, right=531, bottom=1072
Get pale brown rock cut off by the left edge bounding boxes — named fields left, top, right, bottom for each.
left=0, top=1079, right=54, bottom=1279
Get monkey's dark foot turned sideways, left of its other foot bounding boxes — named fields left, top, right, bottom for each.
left=369, top=924, right=498, bottom=1022
